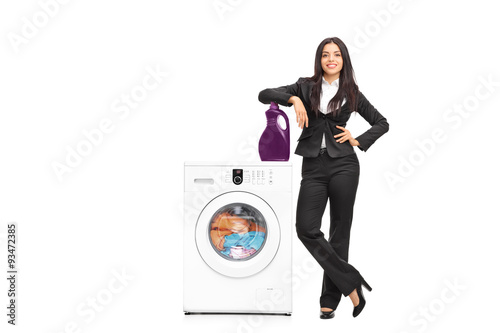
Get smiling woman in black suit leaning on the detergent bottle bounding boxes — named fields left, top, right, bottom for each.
left=259, top=37, right=389, bottom=319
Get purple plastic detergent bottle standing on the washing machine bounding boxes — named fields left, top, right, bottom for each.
left=259, top=102, right=290, bottom=161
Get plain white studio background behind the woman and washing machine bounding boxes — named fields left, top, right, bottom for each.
left=0, top=0, right=500, bottom=333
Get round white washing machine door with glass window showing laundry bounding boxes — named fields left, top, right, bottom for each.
left=195, top=191, right=281, bottom=277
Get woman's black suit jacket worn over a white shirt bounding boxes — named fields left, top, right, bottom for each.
left=259, top=77, right=389, bottom=157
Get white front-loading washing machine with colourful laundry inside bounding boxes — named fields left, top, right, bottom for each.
left=184, top=162, right=292, bottom=315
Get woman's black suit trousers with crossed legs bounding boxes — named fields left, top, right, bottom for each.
left=295, top=151, right=363, bottom=310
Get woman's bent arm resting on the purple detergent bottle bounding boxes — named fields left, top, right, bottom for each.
left=259, top=78, right=309, bottom=128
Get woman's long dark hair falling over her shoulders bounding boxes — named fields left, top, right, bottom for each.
left=307, top=37, right=358, bottom=117
